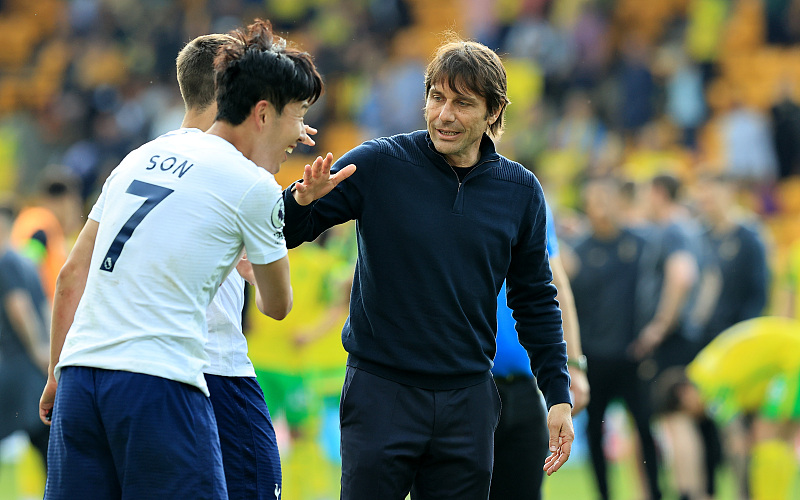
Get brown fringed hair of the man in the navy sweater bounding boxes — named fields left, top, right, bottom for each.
left=425, top=33, right=511, bottom=138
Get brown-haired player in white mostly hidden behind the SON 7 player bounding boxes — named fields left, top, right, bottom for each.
left=177, top=34, right=316, bottom=500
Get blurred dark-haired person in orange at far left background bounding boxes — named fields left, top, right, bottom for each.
left=11, top=170, right=83, bottom=301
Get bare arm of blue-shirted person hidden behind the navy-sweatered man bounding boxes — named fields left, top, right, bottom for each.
left=550, top=254, right=589, bottom=415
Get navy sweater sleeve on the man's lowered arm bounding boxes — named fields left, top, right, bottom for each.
left=506, top=183, right=571, bottom=408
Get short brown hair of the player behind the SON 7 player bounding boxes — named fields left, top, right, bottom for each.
left=175, top=33, right=235, bottom=111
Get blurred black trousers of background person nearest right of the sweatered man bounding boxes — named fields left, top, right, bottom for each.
left=586, top=359, right=661, bottom=500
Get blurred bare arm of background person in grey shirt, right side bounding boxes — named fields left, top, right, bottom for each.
left=633, top=250, right=698, bottom=359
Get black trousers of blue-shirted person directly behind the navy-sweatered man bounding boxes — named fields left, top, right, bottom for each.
left=489, top=377, right=549, bottom=500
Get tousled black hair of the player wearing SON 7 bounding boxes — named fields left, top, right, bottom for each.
left=214, top=19, right=324, bottom=125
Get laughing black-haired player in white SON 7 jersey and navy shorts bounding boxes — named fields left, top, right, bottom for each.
left=40, top=20, right=340, bottom=499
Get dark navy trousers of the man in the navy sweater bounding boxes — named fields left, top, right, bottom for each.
left=340, top=366, right=500, bottom=500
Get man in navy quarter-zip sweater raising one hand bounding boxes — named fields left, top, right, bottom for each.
left=284, top=36, right=574, bottom=500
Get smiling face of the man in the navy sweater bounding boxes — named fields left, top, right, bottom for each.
left=425, top=83, right=500, bottom=167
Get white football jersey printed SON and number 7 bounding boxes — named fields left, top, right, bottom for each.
left=56, top=129, right=287, bottom=395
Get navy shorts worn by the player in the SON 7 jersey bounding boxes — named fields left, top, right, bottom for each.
left=45, top=366, right=228, bottom=500
